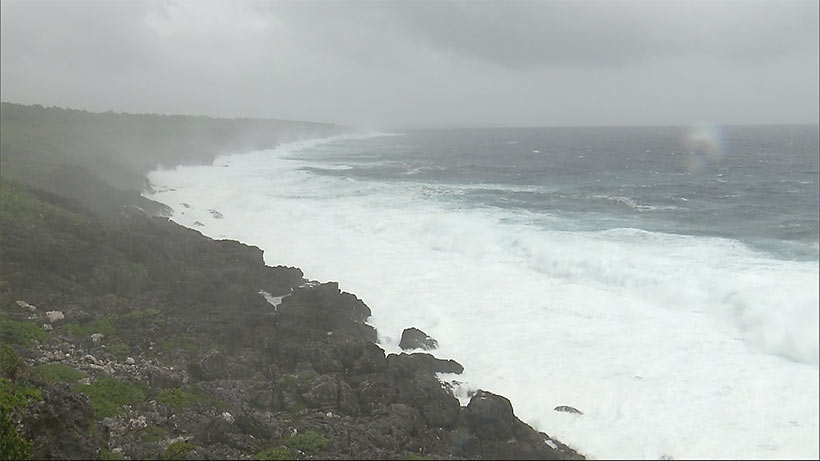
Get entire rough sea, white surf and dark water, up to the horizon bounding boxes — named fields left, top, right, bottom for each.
left=145, top=124, right=820, bottom=459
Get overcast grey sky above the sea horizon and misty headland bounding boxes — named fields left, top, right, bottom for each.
left=0, top=0, right=820, bottom=129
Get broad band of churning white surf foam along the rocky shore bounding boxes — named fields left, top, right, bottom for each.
left=149, top=138, right=820, bottom=458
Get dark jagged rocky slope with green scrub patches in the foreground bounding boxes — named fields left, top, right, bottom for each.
left=0, top=102, right=583, bottom=459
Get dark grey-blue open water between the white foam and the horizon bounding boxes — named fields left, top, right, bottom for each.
left=300, top=126, right=820, bottom=260
